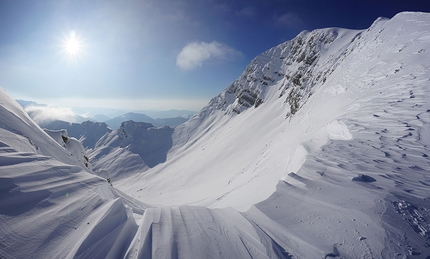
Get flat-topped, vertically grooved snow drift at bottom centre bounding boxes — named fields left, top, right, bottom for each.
left=127, top=206, right=288, bottom=258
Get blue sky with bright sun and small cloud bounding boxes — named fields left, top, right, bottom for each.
left=0, top=0, right=430, bottom=111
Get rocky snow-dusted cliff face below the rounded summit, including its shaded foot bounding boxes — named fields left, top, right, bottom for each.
left=173, top=25, right=362, bottom=152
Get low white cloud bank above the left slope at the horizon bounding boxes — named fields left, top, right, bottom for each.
left=25, top=106, right=77, bottom=124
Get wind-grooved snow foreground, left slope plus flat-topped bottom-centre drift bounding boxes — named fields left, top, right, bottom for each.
left=0, top=88, right=288, bottom=258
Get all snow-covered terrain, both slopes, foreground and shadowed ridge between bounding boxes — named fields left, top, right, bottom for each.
left=0, top=12, right=430, bottom=258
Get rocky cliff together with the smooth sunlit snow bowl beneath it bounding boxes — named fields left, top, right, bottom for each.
left=121, top=28, right=361, bottom=209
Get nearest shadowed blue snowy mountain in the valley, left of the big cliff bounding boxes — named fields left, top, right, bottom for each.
left=89, top=121, right=173, bottom=178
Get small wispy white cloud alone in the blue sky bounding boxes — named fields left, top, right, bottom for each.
left=176, top=41, right=242, bottom=70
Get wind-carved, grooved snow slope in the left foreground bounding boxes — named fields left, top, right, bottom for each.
left=0, top=89, right=146, bottom=258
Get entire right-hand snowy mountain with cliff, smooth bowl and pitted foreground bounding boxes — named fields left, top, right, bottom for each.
left=118, top=13, right=430, bottom=258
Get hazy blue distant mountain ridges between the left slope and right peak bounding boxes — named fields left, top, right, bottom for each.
left=38, top=121, right=173, bottom=179
